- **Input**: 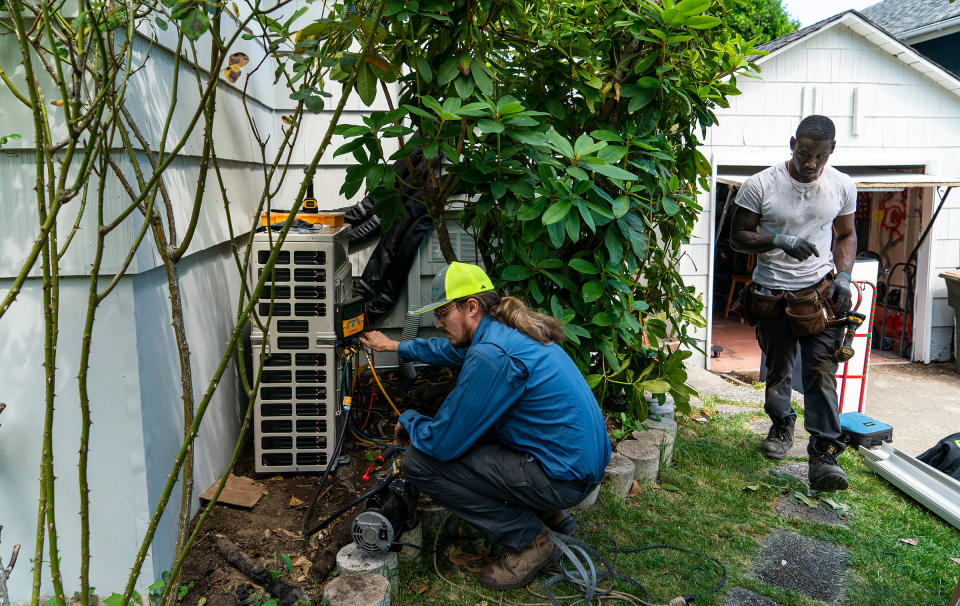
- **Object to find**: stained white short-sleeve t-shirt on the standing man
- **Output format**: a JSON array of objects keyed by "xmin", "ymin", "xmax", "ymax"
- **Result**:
[{"xmin": 735, "ymin": 162, "xmax": 857, "ymax": 290}]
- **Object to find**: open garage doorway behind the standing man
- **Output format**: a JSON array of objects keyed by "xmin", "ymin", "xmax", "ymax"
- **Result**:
[{"xmin": 708, "ymin": 166, "xmax": 960, "ymax": 382}]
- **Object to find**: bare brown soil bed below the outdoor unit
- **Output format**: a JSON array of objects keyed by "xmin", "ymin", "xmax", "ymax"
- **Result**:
[{"xmin": 181, "ymin": 368, "xmax": 456, "ymax": 606}]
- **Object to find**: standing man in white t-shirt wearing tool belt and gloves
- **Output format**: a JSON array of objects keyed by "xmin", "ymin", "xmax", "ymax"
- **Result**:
[{"xmin": 730, "ymin": 116, "xmax": 857, "ymax": 491}]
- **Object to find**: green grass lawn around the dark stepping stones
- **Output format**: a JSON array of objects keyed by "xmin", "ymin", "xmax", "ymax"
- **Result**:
[{"xmin": 393, "ymin": 403, "xmax": 960, "ymax": 606}]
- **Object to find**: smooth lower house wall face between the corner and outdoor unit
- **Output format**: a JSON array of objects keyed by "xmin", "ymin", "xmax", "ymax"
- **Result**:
[{"xmin": 131, "ymin": 244, "xmax": 246, "ymax": 588}]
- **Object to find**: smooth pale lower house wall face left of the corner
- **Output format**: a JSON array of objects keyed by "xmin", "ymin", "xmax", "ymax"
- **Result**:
[{"xmin": 0, "ymin": 278, "xmax": 153, "ymax": 601}]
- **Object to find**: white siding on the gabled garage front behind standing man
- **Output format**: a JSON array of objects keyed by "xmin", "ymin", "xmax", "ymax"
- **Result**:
[{"xmin": 690, "ymin": 15, "xmax": 960, "ymax": 370}]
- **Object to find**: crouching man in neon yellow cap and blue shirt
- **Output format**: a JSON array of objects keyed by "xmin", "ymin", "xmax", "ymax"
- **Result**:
[{"xmin": 362, "ymin": 262, "xmax": 610, "ymax": 590}]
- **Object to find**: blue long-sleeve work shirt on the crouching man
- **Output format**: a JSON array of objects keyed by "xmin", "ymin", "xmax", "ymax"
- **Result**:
[{"xmin": 397, "ymin": 316, "xmax": 610, "ymax": 482}]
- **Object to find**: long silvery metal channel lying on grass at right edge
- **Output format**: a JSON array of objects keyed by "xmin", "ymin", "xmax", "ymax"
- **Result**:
[{"xmin": 860, "ymin": 444, "xmax": 960, "ymax": 530}]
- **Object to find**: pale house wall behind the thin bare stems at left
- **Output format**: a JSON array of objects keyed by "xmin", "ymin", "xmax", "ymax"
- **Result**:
[{"xmin": 0, "ymin": 1, "xmax": 391, "ymax": 601}]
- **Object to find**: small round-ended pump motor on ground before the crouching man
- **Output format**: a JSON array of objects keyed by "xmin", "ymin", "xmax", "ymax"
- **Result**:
[{"xmin": 350, "ymin": 478, "xmax": 419, "ymax": 553}]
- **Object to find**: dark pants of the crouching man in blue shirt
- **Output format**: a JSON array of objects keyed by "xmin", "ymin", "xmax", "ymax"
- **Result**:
[{"xmin": 403, "ymin": 444, "xmax": 594, "ymax": 552}]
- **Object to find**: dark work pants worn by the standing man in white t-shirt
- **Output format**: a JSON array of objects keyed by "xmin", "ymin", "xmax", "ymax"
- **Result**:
[{"xmin": 757, "ymin": 311, "xmax": 843, "ymax": 452}]
